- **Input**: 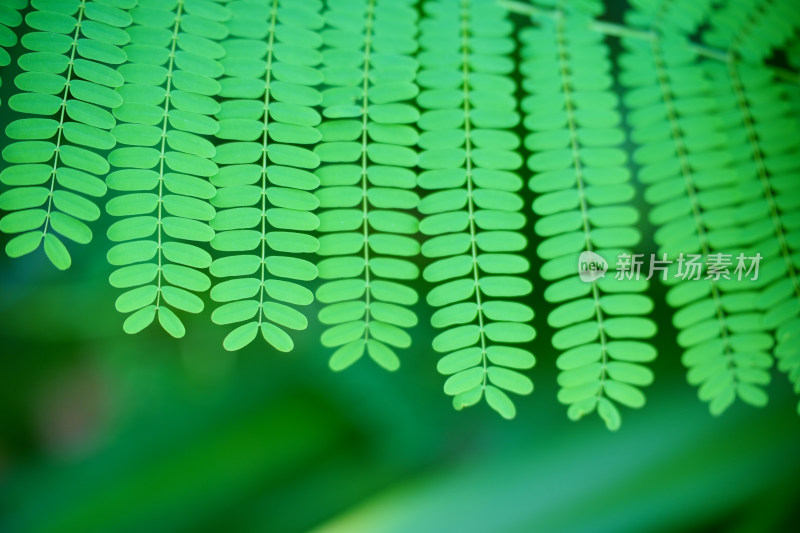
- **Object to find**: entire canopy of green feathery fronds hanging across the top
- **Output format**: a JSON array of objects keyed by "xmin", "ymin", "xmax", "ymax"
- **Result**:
[{"xmin": 0, "ymin": 0, "xmax": 800, "ymax": 424}]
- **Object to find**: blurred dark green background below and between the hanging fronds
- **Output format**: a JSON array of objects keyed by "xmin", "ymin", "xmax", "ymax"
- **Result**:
[{"xmin": 0, "ymin": 1, "xmax": 800, "ymax": 533}]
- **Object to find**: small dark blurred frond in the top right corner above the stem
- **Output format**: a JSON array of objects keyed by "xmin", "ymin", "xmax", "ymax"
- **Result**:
[{"xmin": 703, "ymin": 0, "xmax": 800, "ymax": 62}]
